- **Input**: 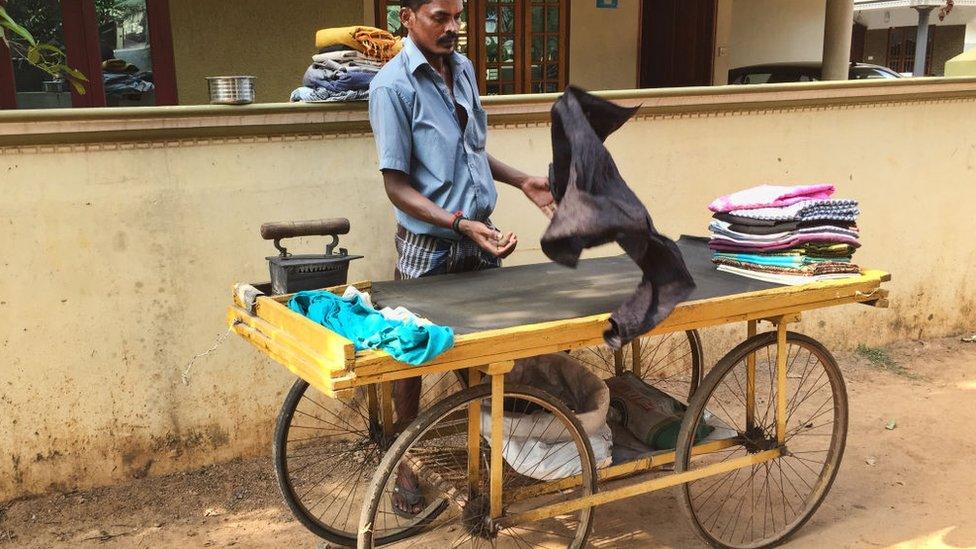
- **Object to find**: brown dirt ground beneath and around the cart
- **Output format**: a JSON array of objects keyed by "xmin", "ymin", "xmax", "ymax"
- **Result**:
[{"xmin": 0, "ymin": 337, "xmax": 976, "ymax": 549}]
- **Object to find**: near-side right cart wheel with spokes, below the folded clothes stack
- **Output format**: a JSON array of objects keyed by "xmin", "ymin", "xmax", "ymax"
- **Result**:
[{"xmin": 675, "ymin": 332, "xmax": 847, "ymax": 548}]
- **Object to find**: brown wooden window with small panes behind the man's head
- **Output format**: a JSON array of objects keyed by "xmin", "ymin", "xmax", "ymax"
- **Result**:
[{"xmin": 376, "ymin": 0, "xmax": 569, "ymax": 95}]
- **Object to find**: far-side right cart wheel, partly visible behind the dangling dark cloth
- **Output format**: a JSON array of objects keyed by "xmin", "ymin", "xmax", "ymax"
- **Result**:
[{"xmin": 573, "ymin": 330, "xmax": 705, "ymax": 402}]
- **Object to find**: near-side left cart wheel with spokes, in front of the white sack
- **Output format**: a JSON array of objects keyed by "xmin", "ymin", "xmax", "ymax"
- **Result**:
[{"xmin": 359, "ymin": 384, "xmax": 597, "ymax": 548}]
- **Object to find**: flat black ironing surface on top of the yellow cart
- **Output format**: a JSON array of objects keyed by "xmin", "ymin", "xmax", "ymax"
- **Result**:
[{"xmin": 370, "ymin": 236, "xmax": 778, "ymax": 334}]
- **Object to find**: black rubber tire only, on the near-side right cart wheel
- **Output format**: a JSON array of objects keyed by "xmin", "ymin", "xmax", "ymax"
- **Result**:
[{"xmin": 675, "ymin": 332, "xmax": 848, "ymax": 549}]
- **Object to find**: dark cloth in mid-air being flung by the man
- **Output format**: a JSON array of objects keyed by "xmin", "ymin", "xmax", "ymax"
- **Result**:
[{"xmin": 542, "ymin": 86, "xmax": 695, "ymax": 349}]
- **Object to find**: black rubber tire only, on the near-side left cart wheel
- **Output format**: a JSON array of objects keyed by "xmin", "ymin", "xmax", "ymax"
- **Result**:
[{"xmin": 357, "ymin": 384, "xmax": 597, "ymax": 548}]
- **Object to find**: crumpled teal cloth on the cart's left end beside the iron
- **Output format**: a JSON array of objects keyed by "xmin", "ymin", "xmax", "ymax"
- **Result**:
[{"xmin": 288, "ymin": 290, "xmax": 454, "ymax": 366}]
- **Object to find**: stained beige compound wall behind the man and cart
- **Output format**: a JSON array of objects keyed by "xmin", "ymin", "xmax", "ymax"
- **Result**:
[{"xmin": 0, "ymin": 83, "xmax": 976, "ymax": 501}]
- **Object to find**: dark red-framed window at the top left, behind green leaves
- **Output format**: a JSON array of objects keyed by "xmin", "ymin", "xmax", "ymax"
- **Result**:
[{"xmin": 0, "ymin": 0, "xmax": 177, "ymax": 109}]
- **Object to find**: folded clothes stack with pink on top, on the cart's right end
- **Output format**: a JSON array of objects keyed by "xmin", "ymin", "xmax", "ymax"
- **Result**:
[{"xmin": 708, "ymin": 185, "xmax": 861, "ymax": 285}]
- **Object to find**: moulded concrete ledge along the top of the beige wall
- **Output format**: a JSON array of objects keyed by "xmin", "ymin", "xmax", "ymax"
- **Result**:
[{"xmin": 0, "ymin": 77, "xmax": 976, "ymax": 147}]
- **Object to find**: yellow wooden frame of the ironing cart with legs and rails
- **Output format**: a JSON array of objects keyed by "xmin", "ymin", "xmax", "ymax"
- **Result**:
[{"xmin": 227, "ymin": 270, "xmax": 890, "ymax": 540}]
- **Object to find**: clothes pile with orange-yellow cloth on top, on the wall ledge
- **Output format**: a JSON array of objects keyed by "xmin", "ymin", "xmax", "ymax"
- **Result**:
[{"xmin": 291, "ymin": 27, "xmax": 402, "ymax": 103}]
